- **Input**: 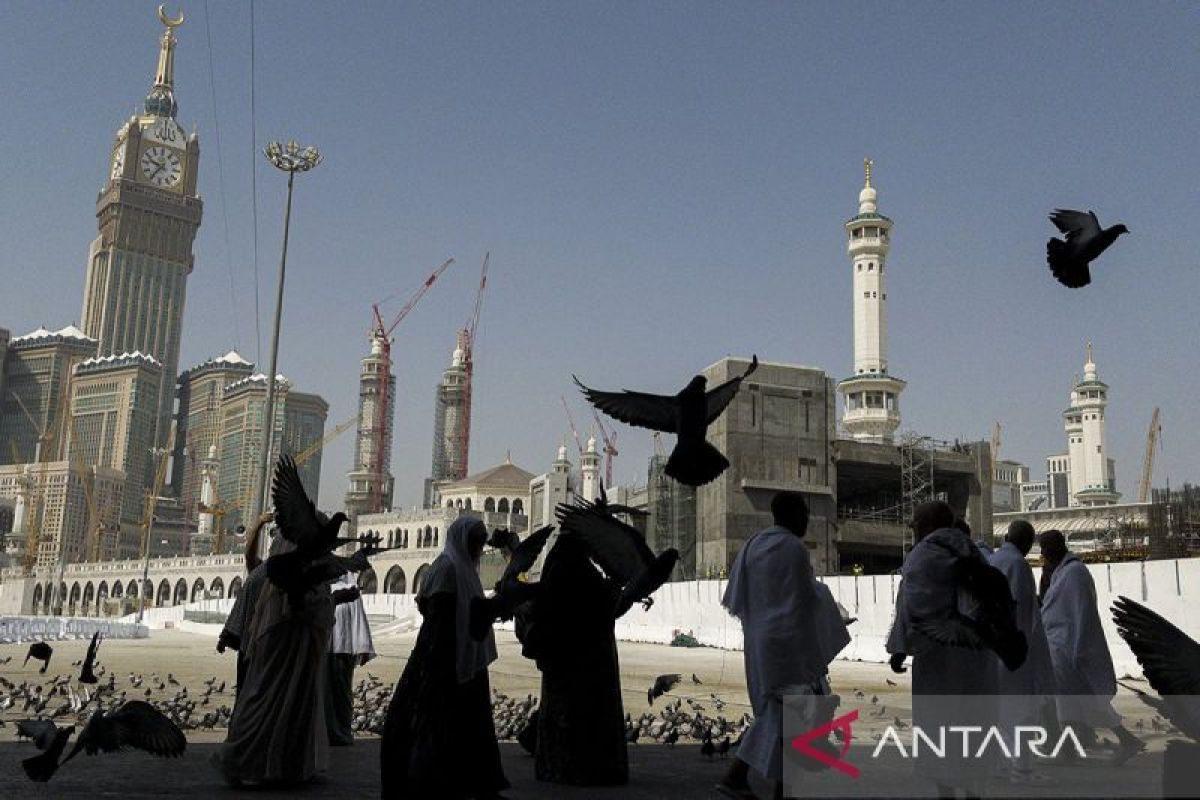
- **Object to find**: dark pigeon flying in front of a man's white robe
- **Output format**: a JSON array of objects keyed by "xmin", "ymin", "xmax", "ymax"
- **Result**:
[{"xmin": 912, "ymin": 558, "xmax": 1028, "ymax": 672}]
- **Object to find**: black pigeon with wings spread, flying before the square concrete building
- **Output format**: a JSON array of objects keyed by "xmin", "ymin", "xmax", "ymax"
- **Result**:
[{"xmin": 572, "ymin": 356, "xmax": 758, "ymax": 486}]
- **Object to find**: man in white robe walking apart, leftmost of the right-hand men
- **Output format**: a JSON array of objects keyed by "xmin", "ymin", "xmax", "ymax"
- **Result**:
[{"xmin": 716, "ymin": 492, "xmax": 850, "ymax": 799}]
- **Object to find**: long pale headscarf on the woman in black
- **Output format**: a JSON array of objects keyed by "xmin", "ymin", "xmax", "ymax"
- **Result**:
[{"xmin": 416, "ymin": 516, "xmax": 497, "ymax": 684}]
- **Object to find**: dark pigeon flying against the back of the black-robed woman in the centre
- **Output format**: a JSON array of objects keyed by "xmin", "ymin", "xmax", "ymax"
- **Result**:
[{"xmin": 554, "ymin": 500, "xmax": 679, "ymax": 616}]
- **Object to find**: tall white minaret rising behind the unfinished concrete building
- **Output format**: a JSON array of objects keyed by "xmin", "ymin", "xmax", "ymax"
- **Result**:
[{"xmin": 838, "ymin": 158, "xmax": 905, "ymax": 443}]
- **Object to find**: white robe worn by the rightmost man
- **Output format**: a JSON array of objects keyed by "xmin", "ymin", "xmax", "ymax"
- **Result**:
[{"xmin": 1042, "ymin": 553, "xmax": 1121, "ymax": 728}]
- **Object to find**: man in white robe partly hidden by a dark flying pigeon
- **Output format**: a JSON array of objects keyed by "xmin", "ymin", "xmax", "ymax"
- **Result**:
[{"xmin": 887, "ymin": 500, "xmax": 996, "ymax": 796}]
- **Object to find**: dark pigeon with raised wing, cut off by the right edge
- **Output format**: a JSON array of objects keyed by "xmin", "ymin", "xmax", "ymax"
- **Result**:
[{"xmin": 1112, "ymin": 596, "xmax": 1200, "ymax": 742}]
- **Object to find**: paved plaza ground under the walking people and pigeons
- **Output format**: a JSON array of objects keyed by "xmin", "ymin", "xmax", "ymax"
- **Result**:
[{"xmin": 0, "ymin": 631, "xmax": 1165, "ymax": 800}]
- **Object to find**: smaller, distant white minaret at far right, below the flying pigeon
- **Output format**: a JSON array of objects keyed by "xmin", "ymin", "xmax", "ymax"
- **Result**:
[{"xmin": 1063, "ymin": 342, "xmax": 1121, "ymax": 506}]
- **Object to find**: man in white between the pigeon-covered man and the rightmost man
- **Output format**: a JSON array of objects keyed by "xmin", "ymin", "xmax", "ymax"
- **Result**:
[{"xmin": 988, "ymin": 519, "xmax": 1055, "ymax": 786}]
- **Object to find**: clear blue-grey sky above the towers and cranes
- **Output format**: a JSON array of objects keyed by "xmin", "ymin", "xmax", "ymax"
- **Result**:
[{"xmin": 0, "ymin": 0, "xmax": 1200, "ymax": 506}]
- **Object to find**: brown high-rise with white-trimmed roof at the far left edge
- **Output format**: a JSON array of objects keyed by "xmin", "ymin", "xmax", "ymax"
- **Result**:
[{"xmin": 0, "ymin": 325, "xmax": 96, "ymax": 464}]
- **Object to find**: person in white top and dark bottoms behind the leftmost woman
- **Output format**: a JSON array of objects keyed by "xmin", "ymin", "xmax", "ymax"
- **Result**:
[{"xmin": 325, "ymin": 572, "xmax": 376, "ymax": 747}]
